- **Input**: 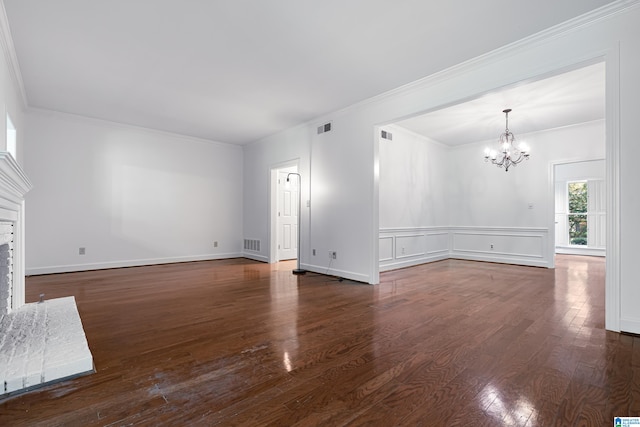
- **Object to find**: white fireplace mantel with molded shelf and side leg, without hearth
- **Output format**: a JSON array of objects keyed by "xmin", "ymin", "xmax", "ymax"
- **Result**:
[{"xmin": 0, "ymin": 151, "xmax": 33, "ymax": 310}]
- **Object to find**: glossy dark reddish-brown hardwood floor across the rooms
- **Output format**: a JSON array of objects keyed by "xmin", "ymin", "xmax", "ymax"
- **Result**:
[{"xmin": 0, "ymin": 256, "xmax": 640, "ymax": 426}]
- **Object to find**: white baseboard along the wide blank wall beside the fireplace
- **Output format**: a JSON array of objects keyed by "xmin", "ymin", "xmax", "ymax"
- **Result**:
[{"xmin": 25, "ymin": 252, "xmax": 244, "ymax": 276}]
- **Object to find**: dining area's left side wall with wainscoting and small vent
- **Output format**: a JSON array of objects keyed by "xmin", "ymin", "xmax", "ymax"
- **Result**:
[{"xmin": 378, "ymin": 125, "xmax": 450, "ymax": 271}]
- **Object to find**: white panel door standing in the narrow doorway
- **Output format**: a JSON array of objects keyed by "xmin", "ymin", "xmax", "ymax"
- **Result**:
[{"xmin": 278, "ymin": 170, "xmax": 299, "ymax": 261}]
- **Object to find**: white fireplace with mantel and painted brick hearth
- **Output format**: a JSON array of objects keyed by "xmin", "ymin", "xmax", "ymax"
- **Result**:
[{"xmin": 0, "ymin": 152, "xmax": 94, "ymax": 399}]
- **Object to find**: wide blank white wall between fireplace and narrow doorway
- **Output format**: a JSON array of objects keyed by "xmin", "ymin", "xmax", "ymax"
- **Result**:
[{"xmin": 25, "ymin": 110, "xmax": 242, "ymax": 274}]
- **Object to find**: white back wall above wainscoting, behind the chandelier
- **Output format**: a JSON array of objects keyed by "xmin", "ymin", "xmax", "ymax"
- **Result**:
[{"xmin": 449, "ymin": 121, "xmax": 605, "ymax": 227}]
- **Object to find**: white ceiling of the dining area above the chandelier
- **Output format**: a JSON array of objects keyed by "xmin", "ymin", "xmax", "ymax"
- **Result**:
[{"xmin": 396, "ymin": 62, "xmax": 605, "ymax": 146}]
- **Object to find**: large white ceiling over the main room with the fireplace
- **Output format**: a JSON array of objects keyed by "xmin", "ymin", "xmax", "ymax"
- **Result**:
[{"xmin": 5, "ymin": 0, "xmax": 612, "ymax": 144}]
